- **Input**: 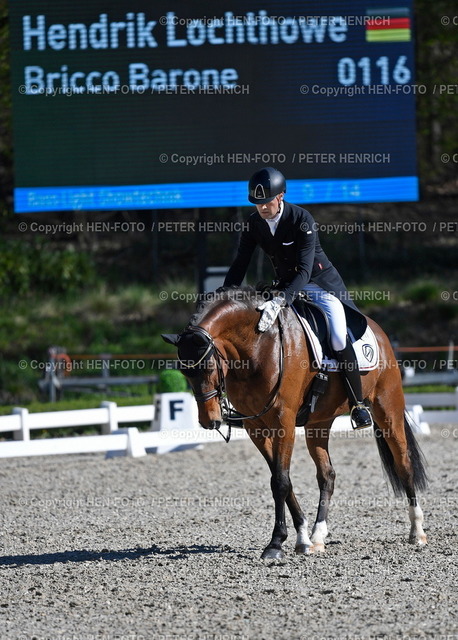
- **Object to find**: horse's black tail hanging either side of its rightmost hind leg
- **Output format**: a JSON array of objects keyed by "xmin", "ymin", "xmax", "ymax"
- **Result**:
[{"xmin": 374, "ymin": 411, "xmax": 428, "ymax": 496}]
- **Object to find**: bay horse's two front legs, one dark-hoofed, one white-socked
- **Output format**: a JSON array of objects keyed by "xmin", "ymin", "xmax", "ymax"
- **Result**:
[{"xmin": 245, "ymin": 424, "xmax": 312, "ymax": 557}]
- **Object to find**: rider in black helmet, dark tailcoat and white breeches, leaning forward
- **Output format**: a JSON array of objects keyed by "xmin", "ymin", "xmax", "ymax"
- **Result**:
[{"xmin": 224, "ymin": 167, "xmax": 373, "ymax": 429}]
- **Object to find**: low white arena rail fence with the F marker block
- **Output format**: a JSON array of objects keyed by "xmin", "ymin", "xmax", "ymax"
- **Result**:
[{"xmin": 0, "ymin": 388, "xmax": 452, "ymax": 457}]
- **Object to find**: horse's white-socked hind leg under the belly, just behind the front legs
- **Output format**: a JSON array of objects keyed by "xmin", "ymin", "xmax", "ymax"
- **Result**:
[{"xmin": 305, "ymin": 422, "xmax": 336, "ymax": 552}]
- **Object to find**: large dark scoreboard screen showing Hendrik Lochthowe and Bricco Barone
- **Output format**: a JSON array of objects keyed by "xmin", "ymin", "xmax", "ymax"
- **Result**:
[{"xmin": 9, "ymin": 0, "xmax": 418, "ymax": 212}]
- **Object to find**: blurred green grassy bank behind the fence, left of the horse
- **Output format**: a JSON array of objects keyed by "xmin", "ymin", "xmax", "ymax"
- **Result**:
[{"xmin": 0, "ymin": 281, "xmax": 194, "ymax": 405}]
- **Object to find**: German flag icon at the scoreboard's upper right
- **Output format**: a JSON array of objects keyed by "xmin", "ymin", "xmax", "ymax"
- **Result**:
[{"xmin": 366, "ymin": 7, "xmax": 411, "ymax": 42}]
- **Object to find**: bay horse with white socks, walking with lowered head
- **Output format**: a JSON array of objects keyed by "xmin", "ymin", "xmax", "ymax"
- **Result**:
[{"xmin": 162, "ymin": 287, "xmax": 427, "ymax": 560}]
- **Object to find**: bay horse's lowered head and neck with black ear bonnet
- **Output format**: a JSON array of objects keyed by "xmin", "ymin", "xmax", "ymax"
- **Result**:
[{"xmin": 162, "ymin": 287, "xmax": 276, "ymax": 429}]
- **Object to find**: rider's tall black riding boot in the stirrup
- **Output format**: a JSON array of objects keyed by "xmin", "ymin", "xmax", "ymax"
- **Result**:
[{"xmin": 335, "ymin": 337, "xmax": 374, "ymax": 429}]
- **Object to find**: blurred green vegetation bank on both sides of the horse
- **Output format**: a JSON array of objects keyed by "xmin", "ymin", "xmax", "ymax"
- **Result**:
[{"xmin": 0, "ymin": 276, "xmax": 458, "ymax": 407}]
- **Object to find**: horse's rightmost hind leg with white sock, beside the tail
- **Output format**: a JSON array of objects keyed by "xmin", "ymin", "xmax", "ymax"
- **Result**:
[{"xmin": 373, "ymin": 388, "xmax": 427, "ymax": 545}]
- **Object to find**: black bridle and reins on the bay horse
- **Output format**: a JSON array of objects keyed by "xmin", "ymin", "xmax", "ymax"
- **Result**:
[{"xmin": 178, "ymin": 316, "xmax": 284, "ymax": 442}]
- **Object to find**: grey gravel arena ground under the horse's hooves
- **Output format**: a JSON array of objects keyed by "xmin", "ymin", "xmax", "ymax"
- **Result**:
[{"xmin": 0, "ymin": 425, "xmax": 458, "ymax": 640}]
